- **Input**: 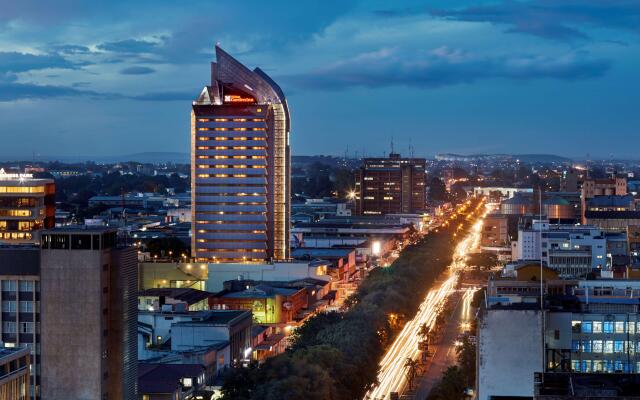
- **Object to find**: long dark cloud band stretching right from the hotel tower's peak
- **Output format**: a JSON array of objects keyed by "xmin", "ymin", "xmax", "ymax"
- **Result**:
[{"xmin": 282, "ymin": 47, "xmax": 610, "ymax": 90}]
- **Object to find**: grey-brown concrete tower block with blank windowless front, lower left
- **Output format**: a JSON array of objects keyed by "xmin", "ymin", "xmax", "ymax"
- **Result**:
[{"xmin": 40, "ymin": 227, "xmax": 137, "ymax": 400}]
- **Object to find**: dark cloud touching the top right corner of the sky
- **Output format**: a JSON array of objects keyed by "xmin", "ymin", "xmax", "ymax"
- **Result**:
[{"xmin": 430, "ymin": 0, "xmax": 640, "ymax": 41}]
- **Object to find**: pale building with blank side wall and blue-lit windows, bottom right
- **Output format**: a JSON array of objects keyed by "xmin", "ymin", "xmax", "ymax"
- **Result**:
[{"xmin": 477, "ymin": 274, "xmax": 640, "ymax": 400}]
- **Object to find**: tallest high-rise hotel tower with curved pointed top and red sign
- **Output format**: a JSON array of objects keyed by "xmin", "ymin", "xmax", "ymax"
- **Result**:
[{"xmin": 191, "ymin": 46, "xmax": 291, "ymax": 263}]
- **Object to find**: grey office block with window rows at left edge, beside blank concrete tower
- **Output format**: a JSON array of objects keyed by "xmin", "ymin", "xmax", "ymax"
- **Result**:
[{"xmin": 0, "ymin": 245, "xmax": 41, "ymax": 399}]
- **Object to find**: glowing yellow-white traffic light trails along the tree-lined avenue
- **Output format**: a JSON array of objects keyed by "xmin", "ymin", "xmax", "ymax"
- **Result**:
[{"xmin": 364, "ymin": 208, "xmax": 486, "ymax": 400}]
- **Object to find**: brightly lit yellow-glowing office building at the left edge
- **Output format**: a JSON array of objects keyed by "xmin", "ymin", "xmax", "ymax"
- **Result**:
[{"xmin": 0, "ymin": 169, "xmax": 56, "ymax": 243}]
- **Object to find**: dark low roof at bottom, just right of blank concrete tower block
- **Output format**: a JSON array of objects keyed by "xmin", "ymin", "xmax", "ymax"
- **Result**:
[{"xmin": 138, "ymin": 363, "xmax": 205, "ymax": 394}]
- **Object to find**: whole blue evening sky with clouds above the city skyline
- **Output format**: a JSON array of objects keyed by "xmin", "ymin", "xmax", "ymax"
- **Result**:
[{"xmin": 0, "ymin": 0, "xmax": 640, "ymax": 158}]
